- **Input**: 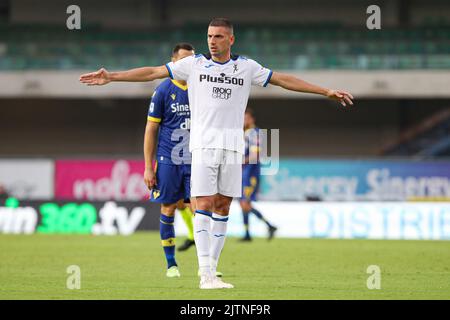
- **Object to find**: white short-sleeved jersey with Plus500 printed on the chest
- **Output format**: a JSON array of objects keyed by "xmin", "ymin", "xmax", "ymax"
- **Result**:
[{"xmin": 166, "ymin": 54, "xmax": 272, "ymax": 153}]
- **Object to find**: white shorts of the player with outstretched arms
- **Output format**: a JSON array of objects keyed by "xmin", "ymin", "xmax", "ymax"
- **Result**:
[{"xmin": 191, "ymin": 149, "xmax": 242, "ymax": 197}]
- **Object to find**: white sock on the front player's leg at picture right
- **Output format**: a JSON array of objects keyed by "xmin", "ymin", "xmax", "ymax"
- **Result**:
[{"xmin": 209, "ymin": 213, "xmax": 228, "ymax": 276}]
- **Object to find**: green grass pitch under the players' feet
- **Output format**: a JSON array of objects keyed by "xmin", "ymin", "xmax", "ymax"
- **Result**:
[{"xmin": 0, "ymin": 232, "xmax": 450, "ymax": 300}]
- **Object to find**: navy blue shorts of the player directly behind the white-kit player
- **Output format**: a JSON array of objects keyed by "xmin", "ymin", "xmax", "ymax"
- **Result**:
[{"xmin": 150, "ymin": 163, "xmax": 191, "ymax": 204}]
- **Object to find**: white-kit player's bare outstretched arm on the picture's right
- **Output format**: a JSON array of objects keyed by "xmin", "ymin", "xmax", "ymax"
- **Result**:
[{"xmin": 270, "ymin": 72, "xmax": 353, "ymax": 107}]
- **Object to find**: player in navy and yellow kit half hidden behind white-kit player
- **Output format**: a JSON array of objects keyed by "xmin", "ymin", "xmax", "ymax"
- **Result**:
[{"xmin": 144, "ymin": 43, "xmax": 195, "ymax": 277}]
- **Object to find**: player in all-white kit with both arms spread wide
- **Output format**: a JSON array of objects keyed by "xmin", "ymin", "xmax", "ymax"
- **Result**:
[{"xmin": 80, "ymin": 18, "xmax": 353, "ymax": 289}]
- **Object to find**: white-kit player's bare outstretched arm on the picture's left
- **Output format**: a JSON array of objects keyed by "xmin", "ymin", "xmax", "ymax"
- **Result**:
[{"xmin": 80, "ymin": 66, "xmax": 169, "ymax": 86}]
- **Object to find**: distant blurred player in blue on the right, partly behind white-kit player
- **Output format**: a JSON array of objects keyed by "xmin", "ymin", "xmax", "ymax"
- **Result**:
[{"xmin": 239, "ymin": 108, "xmax": 277, "ymax": 241}]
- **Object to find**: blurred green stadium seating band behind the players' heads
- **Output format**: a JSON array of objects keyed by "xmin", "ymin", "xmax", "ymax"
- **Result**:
[{"xmin": 0, "ymin": 24, "xmax": 450, "ymax": 70}]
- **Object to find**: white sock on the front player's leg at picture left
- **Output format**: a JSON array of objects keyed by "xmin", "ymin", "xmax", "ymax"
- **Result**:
[{"xmin": 194, "ymin": 210, "xmax": 211, "ymax": 276}]
